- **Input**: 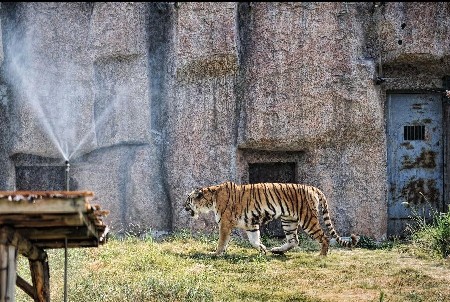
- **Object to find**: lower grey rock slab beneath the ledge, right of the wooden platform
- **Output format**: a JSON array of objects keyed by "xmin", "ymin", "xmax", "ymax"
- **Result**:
[{"xmin": 71, "ymin": 144, "xmax": 171, "ymax": 234}]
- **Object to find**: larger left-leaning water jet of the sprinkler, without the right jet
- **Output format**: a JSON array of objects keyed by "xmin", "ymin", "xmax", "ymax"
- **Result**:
[{"xmin": 8, "ymin": 31, "xmax": 86, "ymax": 160}]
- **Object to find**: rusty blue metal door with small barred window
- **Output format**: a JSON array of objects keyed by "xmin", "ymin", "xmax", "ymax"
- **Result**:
[{"xmin": 387, "ymin": 94, "xmax": 444, "ymax": 236}]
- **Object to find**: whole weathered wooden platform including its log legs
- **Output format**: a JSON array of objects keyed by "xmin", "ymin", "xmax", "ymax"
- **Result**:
[{"xmin": 0, "ymin": 191, "xmax": 108, "ymax": 302}]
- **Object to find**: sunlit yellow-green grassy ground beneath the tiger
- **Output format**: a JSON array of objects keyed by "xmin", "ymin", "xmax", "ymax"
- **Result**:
[{"xmin": 17, "ymin": 232, "xmax": 450, "ymax": 302}]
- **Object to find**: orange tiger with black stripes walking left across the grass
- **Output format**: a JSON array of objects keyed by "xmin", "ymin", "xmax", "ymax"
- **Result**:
[{"xmin": 184, "ymin": 181, "xmax": 358, "ymax": 256}]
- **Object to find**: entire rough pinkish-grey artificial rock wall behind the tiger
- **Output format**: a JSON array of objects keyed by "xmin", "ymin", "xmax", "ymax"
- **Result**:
[{"xmin": 0, "ymin": 2, "xmax": 450, "ymax": 239}]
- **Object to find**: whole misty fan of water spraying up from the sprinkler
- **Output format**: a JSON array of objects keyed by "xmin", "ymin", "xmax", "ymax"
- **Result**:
[{"xmin": 4, "ymin": 6, "xmax": 146, "ymax": 161}]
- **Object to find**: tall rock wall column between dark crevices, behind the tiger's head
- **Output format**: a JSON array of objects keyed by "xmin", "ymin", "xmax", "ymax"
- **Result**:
[{"xmin": 166, "ymin": 2, "xmax": 238, "ymax": 228}]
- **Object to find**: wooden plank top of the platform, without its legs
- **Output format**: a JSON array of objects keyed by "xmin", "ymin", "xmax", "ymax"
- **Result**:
[{"xmin": 0, "ymin": 191, "xmax": 109, "ymax": 248}]
